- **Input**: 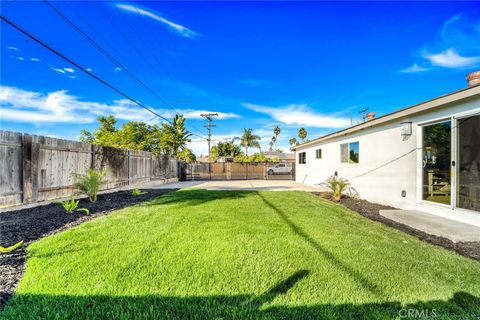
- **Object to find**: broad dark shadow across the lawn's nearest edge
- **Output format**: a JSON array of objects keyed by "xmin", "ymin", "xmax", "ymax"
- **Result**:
[{"xmin": 0, "ymin": 290, "xmax": 480, "ymax": 320}]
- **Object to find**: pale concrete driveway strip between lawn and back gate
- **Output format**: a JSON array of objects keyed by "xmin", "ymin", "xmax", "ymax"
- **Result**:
[{"xmin": 155, "ymin": 180, "xmax": 321, "ymax": 192}]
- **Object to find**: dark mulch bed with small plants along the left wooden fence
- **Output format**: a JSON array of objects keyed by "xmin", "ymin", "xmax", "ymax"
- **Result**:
[{"xmin": 0, "ymin": 189, "xmax": 177, "ymax": 310}]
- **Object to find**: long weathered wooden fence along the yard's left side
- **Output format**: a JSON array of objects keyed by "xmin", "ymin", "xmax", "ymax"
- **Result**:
[{"xmin": 0, "ymin": 130, "xmax": 177, "ymax": 206}]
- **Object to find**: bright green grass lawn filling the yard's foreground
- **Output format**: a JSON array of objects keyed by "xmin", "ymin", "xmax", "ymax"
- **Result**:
[{"xmin": 0, "ymin": 189, "xmax": 480, "ymax": 319}]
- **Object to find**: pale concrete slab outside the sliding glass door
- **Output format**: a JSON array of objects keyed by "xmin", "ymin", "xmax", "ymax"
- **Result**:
[{"xmin": 380, "ymin": 210, "xmax": 480, "ymax": 242}]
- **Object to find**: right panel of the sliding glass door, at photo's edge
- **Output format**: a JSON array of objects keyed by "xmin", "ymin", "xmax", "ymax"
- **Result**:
[{"xmin": 456, "ymin": 115, "xmax": 480, "ymax": 211}]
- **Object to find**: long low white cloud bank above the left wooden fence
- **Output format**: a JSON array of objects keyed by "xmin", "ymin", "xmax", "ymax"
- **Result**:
[{"xmin": 0, "ymin": 87, "xmax": 238, "ymax": 127}]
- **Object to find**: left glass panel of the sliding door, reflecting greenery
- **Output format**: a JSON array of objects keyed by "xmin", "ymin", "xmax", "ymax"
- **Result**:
[{"xmin": 422, "ymin": 120, "xmax": 452, "ymax": 205}]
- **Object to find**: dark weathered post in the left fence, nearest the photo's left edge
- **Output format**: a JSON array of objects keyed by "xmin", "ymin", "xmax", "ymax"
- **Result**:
[{"xmin": 22, "ymin": 134, "xmax": 40, "ymax": 203}]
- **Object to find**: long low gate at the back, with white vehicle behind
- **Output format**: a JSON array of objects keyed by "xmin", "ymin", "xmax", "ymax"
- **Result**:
[{"xmin": 186, "ymin": 162, "xmax": 295, "ymax": 180}]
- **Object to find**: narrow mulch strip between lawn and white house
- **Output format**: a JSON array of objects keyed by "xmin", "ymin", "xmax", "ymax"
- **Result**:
[{"xmin": 314, "ymin": 192, "xmax": 480, "ymax": 261}]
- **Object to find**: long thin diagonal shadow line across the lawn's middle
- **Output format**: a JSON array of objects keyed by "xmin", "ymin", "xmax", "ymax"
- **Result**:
[{"xmin": 257, "ymin": 193, "xmax": 384, "ymax": 296}]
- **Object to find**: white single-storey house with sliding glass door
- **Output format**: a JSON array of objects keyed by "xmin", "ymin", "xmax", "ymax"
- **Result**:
[{"xmin": 293, "ymin": 72, "xmax": 480, "ymax": 226}]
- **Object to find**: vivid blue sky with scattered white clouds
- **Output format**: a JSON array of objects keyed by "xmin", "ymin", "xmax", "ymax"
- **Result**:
[{"xmin": 0, "ymin": 1, "xmax": 480, "ymax": 154}]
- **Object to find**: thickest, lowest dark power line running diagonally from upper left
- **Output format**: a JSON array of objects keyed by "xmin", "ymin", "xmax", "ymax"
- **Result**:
[{"xmin": 0, "ymin": 15, "xmax": 171, "ymax": 123}]
